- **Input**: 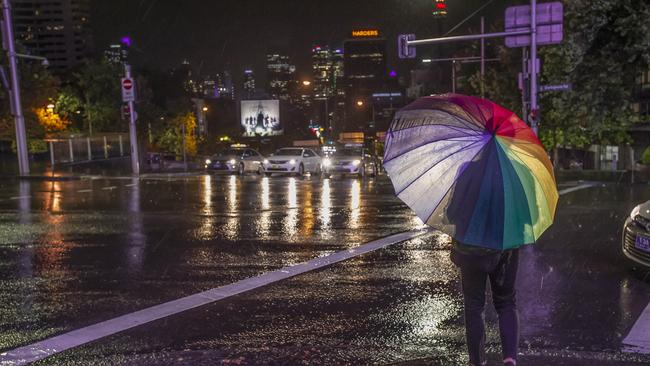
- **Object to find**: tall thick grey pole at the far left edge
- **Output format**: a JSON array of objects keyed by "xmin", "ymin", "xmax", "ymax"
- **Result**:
[{"xmin": 2, "ymin": 0, "xmax": 29, "ymax": 176}]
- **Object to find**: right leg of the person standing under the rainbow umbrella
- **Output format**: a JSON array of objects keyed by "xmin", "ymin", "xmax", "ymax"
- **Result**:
[{"xmin": 489, "ymin": 249, "xmax": 519, "ymax": 364}]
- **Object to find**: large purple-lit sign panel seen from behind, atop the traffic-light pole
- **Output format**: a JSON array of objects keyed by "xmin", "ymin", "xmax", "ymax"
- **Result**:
[{"xmin": 505, "ymin": 2, "xmax": 564, "ymax": 48}]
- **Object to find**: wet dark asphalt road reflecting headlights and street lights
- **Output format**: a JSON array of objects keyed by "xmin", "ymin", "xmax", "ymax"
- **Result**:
[{"xmin": 0, "ymin": 176, "xmax": 650, "ymax": 365}]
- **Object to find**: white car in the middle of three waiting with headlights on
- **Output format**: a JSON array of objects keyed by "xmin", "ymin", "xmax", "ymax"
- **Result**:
[{"xmin": 264, "ymin": 147, "xmax": 322, "ymax": 176}]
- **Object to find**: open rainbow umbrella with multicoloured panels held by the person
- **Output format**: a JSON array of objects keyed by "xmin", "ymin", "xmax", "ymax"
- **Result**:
[{"xmin": 384, "ymin": 94, "xmax": 558, "ymax": 250}]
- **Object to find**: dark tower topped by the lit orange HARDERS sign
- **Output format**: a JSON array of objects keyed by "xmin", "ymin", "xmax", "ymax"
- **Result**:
[{"xmin": 340, "ymin": 29, "xmax": 387, "ymax": 132}]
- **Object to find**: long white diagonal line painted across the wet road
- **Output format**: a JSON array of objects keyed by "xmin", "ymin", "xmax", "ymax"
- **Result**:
[{"xmin": 0, "ymin": 230, "xmax": 430, "ymax": 366}]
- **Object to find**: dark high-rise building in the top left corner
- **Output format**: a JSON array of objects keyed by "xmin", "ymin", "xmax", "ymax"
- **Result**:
[{"xmin": 12, "ymin": 0, "xmax": 92, "ymax": 71}]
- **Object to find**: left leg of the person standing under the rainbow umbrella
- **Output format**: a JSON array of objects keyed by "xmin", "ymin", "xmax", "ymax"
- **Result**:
[{"xmin": 461, "ymin": 267, "xmax": 487, "ymax": 365}]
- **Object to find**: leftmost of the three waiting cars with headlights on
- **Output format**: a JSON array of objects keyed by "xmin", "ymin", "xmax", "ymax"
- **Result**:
[{"xmin": 205, "ymin": 145, "xmax": 264, "ymax": 175}]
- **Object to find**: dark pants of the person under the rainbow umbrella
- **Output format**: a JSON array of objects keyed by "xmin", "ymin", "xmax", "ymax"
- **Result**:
[{"xmin": 452, "ymin": 249, "xmax": 519, "ymax": 365}]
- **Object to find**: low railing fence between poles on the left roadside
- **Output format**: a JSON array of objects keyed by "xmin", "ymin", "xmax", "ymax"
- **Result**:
[{"xmin": 46, "ymin": 133, "xmax": 130, "ymax": 165}]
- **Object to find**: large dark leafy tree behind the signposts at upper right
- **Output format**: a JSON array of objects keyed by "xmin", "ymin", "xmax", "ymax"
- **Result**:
[{"xmin": 540, "ymin": 0, "xmax": 650, "ymax": 155}]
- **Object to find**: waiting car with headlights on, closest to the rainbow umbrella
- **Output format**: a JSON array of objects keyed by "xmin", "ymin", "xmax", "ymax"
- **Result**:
[{"xmin": 323, "ymin": 145, "xmax": 379, "ymax": 177}]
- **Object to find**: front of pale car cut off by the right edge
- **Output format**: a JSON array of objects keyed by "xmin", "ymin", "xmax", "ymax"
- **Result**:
[{"xmin": 622, "ymin": 201, "xmax": 650, "ymax": 269}]
